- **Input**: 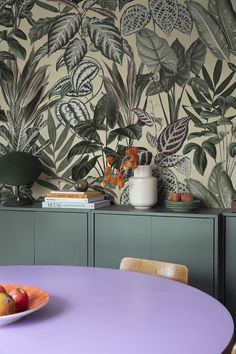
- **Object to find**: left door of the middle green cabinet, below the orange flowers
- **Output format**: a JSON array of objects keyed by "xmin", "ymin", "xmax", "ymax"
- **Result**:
[{"xmin": 94, "ymin": 214, "xmax": 151, "ymax": 268}]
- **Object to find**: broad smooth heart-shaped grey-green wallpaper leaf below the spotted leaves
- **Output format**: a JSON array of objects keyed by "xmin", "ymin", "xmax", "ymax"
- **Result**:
[{"xmin": 136, "ymin": 29, "xmax": 177, "ymax": 74}]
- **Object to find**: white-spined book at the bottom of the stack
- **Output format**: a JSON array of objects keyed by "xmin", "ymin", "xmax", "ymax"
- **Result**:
[{"xmin": 42, "ymin": 200, "xmax": 110, "ymax": 209}]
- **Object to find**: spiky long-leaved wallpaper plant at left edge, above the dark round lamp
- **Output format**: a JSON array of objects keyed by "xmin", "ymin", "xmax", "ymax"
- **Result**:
[{"xmin": 0, "ymin": 51, "xmax": 49, "ymax": 155}]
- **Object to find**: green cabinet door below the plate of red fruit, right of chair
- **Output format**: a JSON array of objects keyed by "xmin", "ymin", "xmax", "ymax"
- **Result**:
[{"xmin": 152, "ymin": 216, "xmax": 218, "ymax": 296}]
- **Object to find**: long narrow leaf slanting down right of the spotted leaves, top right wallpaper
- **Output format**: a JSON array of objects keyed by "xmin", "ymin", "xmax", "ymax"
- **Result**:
[{"xmin": 187, "ymin": 1, "xmax": 230, "ymax": 61}]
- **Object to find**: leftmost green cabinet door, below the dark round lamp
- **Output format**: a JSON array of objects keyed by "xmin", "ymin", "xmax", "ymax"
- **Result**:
[{"xmin": 0, "ymin": 209, "xmax": 34, "ymax": 265}]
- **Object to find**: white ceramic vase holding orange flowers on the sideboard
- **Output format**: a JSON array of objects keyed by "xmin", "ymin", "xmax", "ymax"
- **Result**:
[{"xmin": 129, "ymin": 165, "xmax": 157, "ymax": 209}]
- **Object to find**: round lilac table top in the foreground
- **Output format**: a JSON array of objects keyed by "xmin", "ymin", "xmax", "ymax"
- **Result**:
[{"xmin": 0, "ymin": 266, "xmax": 233, "ymax": 354}]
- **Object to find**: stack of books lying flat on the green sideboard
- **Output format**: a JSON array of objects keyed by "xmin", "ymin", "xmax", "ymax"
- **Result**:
[{"xmin": 42, "ymin": 190, "xmax": 110, "ymax": 209}]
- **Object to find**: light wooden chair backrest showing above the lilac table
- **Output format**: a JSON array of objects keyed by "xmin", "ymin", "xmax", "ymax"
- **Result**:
[{"xmin": 120, "ymin": 257, "xmax": 188, "ymax": 284}]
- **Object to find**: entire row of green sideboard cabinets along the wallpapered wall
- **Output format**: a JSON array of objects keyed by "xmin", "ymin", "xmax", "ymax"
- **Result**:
[{"xmin": 0, "ymin": 203, "xmax": 236, "ymax": 319}]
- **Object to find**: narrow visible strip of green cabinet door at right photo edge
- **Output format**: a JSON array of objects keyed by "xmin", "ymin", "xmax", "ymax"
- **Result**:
[{"xmin": 224, "ymin": 214, "xmax": 236, "ymax": 325}]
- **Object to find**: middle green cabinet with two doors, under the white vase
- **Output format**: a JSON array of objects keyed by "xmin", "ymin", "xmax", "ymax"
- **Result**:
[{"xmin": 92, "ymin": 206, "xmax": 223, "ymax": 299}]
